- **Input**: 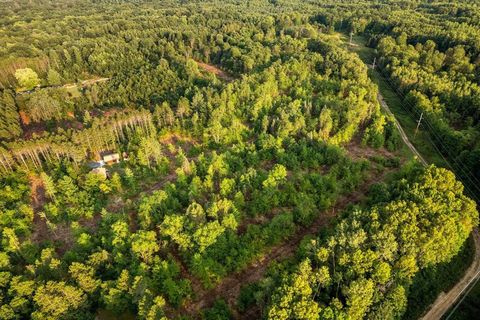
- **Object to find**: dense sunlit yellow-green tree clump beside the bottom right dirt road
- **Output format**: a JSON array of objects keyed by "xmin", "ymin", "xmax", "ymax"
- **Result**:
[{"xmin": 267, "ymin": 167, "xmax": 478, "ymax": 319}]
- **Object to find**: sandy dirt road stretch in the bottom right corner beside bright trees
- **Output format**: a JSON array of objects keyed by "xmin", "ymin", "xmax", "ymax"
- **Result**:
[{"xmin": 422, "ymin": 230, "xmax": 480, "ymax": 320}]
